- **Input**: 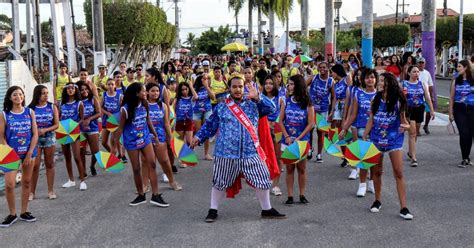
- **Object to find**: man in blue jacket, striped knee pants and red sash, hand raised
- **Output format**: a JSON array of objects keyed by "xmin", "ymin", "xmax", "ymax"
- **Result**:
[{"xmin": 191, "ymin": 76, "xmax": 286, "ymax": 222}]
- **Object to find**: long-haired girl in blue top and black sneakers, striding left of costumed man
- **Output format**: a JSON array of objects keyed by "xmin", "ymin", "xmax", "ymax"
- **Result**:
[{"xmin": 115, "ymin": 83, "xmax": 169, "ymax": 207}]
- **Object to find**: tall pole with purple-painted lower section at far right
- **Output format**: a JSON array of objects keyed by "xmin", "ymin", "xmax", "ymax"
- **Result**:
[{"xmin": 421, "ymin": 0, "xmax": 437, "ymax": 106}]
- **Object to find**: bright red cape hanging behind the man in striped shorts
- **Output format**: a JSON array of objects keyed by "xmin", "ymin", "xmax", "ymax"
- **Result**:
[{"xmin": 226, "ymin": 116, "xmax": 280, "ymax": 198}]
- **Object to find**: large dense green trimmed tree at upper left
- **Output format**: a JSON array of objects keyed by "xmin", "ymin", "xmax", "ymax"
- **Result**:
[{"xmin": 84, "ymin": 0, "xmax": 176, "ymax": 69}]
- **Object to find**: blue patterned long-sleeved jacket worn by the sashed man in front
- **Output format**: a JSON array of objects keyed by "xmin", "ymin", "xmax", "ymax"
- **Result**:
[{"xmin": 196, "ymin": 94, "xmax": 276, "ymax": 159}]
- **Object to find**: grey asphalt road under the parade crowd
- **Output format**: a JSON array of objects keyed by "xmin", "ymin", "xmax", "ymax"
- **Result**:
[{"xmin": 0, "ymin": 126, "xmax": 474, "ymax": 247}]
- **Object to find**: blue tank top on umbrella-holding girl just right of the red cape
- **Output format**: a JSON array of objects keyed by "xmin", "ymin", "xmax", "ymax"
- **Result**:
[{"xmin": 281, "ymin": 97, "xmax": 309, "ymax": 144}]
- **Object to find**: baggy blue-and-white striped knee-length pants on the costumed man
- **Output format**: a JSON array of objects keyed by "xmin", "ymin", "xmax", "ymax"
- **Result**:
[{"xmin": 212, "ymin": 156, "xmax": 272, "ymax": 191}]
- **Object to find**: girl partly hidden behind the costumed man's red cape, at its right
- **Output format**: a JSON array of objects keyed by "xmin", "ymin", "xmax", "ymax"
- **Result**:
[{"xmin": 263, "ymin": 76, "xmax": 286, "ymax": 196}]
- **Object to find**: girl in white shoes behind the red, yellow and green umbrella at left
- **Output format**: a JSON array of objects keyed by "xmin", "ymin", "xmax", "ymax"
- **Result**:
[{"xmin": 59, "ymin": 83, "xmax": 87, "ymax": 190}]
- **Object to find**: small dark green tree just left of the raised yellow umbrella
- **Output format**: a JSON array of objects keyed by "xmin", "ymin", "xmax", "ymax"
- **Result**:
[{"xmin": 195, "ymin": 25, "xmax": 232, "ymax": 55}]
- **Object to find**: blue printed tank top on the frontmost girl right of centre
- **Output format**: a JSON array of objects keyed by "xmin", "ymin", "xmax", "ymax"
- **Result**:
[{"xmin": 370, "ymin": 100, "xmax": 404, "ymax": 152}]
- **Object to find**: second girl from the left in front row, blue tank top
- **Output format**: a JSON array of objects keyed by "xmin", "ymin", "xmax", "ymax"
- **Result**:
[{"xmin": 28, "ymin": 84, "xmax": 59, "ymax": 200}]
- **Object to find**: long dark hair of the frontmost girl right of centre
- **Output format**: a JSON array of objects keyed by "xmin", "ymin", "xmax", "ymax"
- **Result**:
[{"xmin": 371, "ymin": 72, "xmax": 407, "ymax": 115}]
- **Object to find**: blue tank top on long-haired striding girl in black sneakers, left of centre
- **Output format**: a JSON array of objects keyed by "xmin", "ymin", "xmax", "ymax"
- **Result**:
[{"xmin": 122, "ymin": 104, "xmax": 151, "ymax": 150}]
